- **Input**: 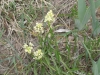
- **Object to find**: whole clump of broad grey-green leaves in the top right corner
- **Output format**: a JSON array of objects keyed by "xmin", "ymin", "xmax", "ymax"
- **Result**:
[{"xmin": 75, "ymin": 0, "xmax": 100, "ymax": 35}]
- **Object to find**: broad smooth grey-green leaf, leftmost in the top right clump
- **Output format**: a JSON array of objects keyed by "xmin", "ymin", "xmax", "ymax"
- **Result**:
[{"xmin": 75, "ymin": 0, "xmax": 91, "ymax": 30}]
